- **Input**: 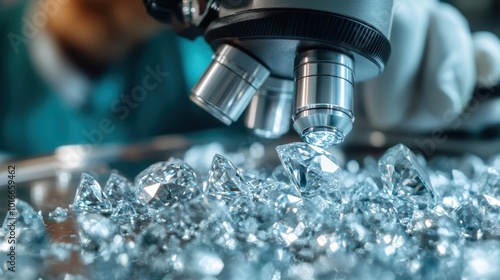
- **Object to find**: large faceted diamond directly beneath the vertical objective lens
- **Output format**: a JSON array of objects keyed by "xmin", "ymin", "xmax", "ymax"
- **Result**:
[{"xmin": 276, "ymin": 143, "xmax": 341, "ymax": 193}]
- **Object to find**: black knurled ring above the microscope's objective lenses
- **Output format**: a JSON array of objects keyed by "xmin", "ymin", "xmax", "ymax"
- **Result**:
[{"xmin": 205, "ymin": 8, "xmax": 391, "ymax": 75}]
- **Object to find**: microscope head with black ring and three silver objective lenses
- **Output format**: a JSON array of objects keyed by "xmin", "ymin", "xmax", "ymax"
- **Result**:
[{"xmin": 144, "ymin": 0, "xmax": 393, "ymax": 146}]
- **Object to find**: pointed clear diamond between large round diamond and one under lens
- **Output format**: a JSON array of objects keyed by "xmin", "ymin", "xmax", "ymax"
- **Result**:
[{"xmin": 208, "ymin": 155, "xmax": 250, "ymax": 195}]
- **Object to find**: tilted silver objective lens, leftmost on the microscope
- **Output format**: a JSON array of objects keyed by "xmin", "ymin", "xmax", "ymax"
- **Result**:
[{"xmin": 190, "ymin": 45, "xmax": 270, "ymax": 125}]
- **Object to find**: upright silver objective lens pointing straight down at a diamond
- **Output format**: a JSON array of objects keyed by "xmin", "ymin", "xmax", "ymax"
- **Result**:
[{"xmin": 293, "ymin": 50, "xmax": 354, "ymax": 146}]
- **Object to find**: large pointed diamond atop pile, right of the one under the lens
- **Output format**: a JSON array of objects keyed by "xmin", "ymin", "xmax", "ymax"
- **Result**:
[{"xmin": 378, "ymin": 144, "xmax": 435, "ymax": 205}]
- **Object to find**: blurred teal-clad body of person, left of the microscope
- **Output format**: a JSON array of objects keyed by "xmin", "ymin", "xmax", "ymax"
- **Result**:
[{"xmin": 0, "ymin": 0, "xmax": 219, "ymax": 156}]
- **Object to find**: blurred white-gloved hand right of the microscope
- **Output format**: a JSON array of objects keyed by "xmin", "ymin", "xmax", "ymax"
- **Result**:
[{"xmin": 357, "ymin": 0, "xmax": 500, "ymax": 133}]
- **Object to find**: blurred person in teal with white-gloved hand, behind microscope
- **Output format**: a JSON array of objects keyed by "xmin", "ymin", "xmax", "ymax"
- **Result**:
[{"xmin": 0, "ymin": 0, "xmax": 500, "ymax": 158}]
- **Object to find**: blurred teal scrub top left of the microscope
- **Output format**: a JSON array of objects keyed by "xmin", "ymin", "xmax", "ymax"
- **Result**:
[{"xmin": 0, "ymin": 1, "xmax": 218, "ymax": 156}]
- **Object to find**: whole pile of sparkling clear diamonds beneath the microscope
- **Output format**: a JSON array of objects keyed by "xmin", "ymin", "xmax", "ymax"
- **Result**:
[{"xmin": 0, "ymin": 143, "xmax": 500, "ymax": 279}]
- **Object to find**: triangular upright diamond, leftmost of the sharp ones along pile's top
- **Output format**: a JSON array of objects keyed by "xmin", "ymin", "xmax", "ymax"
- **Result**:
[{"xmin": 73, "ymin": 173, "xmax": 112, "ymax": 213}]
